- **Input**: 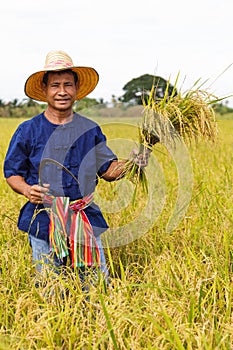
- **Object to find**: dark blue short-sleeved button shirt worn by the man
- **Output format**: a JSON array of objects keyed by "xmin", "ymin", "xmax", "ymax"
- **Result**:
[{"xmin": 4, "ymin": 113, "xmax": 117, "ymax": 241}]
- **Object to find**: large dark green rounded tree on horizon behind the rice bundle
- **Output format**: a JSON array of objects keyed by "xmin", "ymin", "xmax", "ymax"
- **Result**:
[{"xmin": 120, "ymin": 74, "xmax": 174, "ymax": 105}]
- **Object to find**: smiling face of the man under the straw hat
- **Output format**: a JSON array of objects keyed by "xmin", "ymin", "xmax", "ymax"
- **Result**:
[{"xmin": 42, "ymin": 72, "xmax": 78, "ymax": 111}]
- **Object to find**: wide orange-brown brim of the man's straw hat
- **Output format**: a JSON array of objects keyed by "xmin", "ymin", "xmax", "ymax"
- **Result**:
[{"xmin": 24, "ymin": 67, "xmax": 99, "ymax": 102}]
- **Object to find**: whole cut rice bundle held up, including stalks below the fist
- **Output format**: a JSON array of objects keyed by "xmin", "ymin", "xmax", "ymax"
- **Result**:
[{"xmin": 125, "ymin": 76, "xmax": 222, "ymax": 196}]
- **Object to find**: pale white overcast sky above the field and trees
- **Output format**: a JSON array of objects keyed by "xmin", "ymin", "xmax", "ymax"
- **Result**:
[{"xmin": 0, "ymin": 0, "xmax": 233, "ymax": 106}]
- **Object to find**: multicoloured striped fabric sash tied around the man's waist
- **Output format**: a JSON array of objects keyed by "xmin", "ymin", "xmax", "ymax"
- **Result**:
[{"xmin": 44, "ymin": 194, "xmax": 100, "ymax": 267}]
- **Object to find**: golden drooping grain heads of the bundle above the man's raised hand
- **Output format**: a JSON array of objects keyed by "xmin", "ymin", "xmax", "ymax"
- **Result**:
[{"xmin": 140, "ymin": 77, "xmax": 220, "ymax": 143}]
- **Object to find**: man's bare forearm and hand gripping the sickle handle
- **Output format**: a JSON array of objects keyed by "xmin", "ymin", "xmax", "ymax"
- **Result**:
[{"xmin": 6, "ymin": 175, "xmax": 49, "ymax": 204}]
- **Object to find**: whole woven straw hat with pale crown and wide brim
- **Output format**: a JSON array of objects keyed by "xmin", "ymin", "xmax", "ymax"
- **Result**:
[{"xmin": 24, "ymin": 51, "xmax": 99, "ymax": 102}]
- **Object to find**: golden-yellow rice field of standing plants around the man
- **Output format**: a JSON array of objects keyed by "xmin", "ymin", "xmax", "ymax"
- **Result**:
[{"xmin": 0, "ymin": 117, "xmax": 233, "ymax": 350}]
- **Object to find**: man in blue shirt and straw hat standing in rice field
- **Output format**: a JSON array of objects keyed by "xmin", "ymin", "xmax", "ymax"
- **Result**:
[{"xmin": 4, "ymin": 51, "xmax": 147, "ymax": 284}]
